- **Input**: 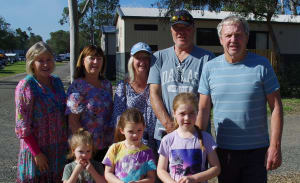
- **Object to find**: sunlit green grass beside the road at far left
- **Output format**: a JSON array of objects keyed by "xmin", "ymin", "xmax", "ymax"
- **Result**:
[{"xmin": 0, "ymin": 61, "xmax": 65, "ymax": 78}]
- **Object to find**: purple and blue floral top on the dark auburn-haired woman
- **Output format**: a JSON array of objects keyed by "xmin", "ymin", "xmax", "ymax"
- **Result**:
[{"xmin": 66, "ymin": 79, "xmax": 114, "ymax": 150}]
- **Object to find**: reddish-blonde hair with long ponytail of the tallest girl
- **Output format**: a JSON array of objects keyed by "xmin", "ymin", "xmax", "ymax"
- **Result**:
[{"xmin": 172, "ymin": 92, "xmax": 205, "ymax": 151}]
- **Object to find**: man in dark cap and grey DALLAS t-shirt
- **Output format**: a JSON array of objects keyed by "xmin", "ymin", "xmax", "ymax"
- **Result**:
[{"xmin": 148, "ymin": 10, "xmax": 214, "ymax": 143}]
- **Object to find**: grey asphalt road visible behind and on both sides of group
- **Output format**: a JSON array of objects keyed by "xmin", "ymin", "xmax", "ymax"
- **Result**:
[{"xmin": 0, "ymin": 61, "xmax": 300, "ymax": 183}]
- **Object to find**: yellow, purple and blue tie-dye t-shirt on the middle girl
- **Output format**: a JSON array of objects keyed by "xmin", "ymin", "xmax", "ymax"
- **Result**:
[{"xmin": 102, "ymin": 141, "xmax": 156, "ymax": 183}]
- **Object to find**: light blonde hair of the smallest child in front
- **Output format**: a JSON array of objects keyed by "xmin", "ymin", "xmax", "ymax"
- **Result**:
[{"xmin": 67, "ymin": 128, "xmax": 94, "ymax": 159}]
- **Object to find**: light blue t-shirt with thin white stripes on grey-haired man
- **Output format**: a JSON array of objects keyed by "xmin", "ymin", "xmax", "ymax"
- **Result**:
[{"xmin": 199, "ymin": 53, "xmax": 279, "ymax": 150}]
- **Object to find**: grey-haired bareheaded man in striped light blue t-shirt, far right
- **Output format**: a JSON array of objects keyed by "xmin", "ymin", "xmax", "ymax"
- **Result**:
[{"xmin": 198, "ymin": 16, "xmax": 283, "ymax": 183}]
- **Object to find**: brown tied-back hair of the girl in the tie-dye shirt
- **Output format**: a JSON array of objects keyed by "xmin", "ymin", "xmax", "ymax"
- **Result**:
[{"xmin": 114, "ymin": 108, "xmax": 145, "ymax": 142}]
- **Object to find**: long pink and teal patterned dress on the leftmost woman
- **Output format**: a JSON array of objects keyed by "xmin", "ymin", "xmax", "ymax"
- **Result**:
[{"xmin": 15, "ymin": 75, "xmax": 67, "ymax": 183}]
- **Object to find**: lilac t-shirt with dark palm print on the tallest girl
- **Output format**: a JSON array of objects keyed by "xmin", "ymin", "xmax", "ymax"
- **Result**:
[{"xmin": 158, "ymin": 130, "xmax": 217, "ymax": 181}]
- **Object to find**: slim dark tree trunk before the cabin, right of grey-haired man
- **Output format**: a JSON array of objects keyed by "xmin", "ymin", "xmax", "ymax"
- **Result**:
[{"xmin": 267, "ymin": 18, "xmax": 283, "ymax": 73}]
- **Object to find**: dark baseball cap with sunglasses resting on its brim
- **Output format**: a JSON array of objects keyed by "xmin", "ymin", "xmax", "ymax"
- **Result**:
[{"xmin": 170, "ymin": 10, "xmax": 194, "ymax": 26}]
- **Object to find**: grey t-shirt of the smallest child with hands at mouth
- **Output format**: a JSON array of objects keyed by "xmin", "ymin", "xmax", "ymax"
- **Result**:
[{"xmin": 62, "ymin": 160, "xmax": 104, "ymax": 183}]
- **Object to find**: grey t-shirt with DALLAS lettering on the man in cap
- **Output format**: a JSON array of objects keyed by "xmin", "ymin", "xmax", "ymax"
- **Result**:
[{"xmin": 148, "ymin": 46, "xmax": 215, "ymax": 140}]
